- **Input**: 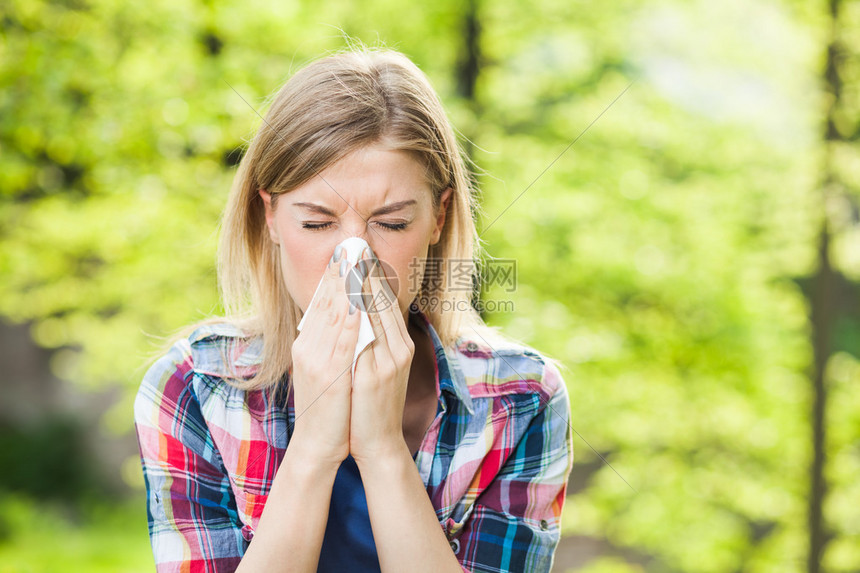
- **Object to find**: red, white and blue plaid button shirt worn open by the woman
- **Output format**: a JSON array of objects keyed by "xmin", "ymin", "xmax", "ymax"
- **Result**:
[{"xmin": 134, "ymin": 314, "xmax": 573, "ymax": 573}]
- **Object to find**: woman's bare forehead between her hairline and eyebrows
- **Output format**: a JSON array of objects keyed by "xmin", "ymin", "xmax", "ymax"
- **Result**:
[{"xmin": 289, "ymin": 146, "xmax": 430, "ymax": 208}]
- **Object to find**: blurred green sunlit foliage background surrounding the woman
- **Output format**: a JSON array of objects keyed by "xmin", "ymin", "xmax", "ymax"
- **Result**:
[{"xmin": 0, "ymin": 0, "xmax": 860, "ymax": 573}]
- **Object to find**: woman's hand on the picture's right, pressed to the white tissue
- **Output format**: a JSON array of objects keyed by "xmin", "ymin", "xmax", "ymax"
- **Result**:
[{"xmin": 349, "ymin": 250, "xmax": 415, "ymax": 466}]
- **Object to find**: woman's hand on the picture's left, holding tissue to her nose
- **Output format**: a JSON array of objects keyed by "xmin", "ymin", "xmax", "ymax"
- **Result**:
[{"xmin": 289, "ymin": 249, "xmax": 360, "ymax": 468}]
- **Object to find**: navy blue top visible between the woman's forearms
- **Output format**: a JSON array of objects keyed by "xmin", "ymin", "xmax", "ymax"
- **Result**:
[{"xmin": 317, "ymin": 452, "xmax": 417, "ymax": 573}]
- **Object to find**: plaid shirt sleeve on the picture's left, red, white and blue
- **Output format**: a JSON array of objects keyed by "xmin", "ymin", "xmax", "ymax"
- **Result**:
[{"xmin": 134, "ymin": 340, "xmax": 248, "ymax": 573}]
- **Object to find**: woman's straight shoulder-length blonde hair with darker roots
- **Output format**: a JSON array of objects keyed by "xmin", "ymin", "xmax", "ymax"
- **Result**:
[{"xmin": 182, "ymin": 47, "xmax": 552, "ymax": 390}]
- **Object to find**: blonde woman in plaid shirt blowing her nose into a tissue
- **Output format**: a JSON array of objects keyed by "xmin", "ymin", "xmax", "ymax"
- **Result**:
[{"xmin": 135, "ymin": 45, "xmax": 573, "ymax": 573}]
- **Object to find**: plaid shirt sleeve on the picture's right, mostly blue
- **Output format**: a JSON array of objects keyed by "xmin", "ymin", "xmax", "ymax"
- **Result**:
[{"xmin": 452, "ymin": 363, "xmax": 573, "ymax": 573}]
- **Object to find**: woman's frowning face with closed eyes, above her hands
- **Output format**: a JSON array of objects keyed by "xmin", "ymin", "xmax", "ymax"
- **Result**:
[{"xmin": 260, "ymin": 145, "xmax": 451, "ymax": 318}]
